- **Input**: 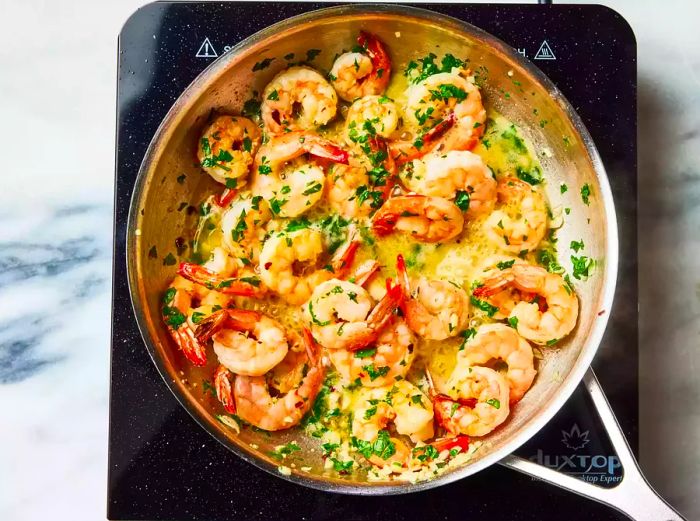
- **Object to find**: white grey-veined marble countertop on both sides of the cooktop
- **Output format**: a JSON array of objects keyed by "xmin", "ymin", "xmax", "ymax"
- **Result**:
[{"xmin": 0, "ymin": 0, "xmax": 700, "ymax": 521}]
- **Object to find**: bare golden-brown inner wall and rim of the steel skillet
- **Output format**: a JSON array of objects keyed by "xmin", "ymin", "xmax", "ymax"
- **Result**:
[{"xmin": 127, "ymin": 4, "xmax": 617, "ymax": 494}]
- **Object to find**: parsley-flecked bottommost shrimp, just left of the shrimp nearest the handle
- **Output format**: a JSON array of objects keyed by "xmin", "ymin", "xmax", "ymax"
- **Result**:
[{"xmin": 352, "ymin": 380, "xmax": 433, "ymax": 442}]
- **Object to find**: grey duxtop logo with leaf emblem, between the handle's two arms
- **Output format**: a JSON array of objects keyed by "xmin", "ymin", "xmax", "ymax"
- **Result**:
[{"xmin": 530, "ymin": 423, "xmax": 622, "ymax": 484}]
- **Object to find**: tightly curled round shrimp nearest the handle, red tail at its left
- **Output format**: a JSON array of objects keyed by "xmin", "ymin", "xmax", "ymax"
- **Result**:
[{"xmin": 432, "ymin": 366, "xmax": 510, "ymax": 436}]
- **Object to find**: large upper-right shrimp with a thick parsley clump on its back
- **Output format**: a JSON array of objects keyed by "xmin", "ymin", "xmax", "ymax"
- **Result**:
[{"xmin": 392, "ymin": 71, "xmax": 486, "ymax": 162}]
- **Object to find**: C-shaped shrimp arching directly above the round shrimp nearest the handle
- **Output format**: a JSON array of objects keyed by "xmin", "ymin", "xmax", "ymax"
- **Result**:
[{"xmin": 457, "ymin": 324, "xmax": 537, "ymax": 404}]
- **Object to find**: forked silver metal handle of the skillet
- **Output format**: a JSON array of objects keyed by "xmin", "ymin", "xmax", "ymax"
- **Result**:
[{"xmin": 499, "ymin": 369, "xmax": 685, "ymax": 521}]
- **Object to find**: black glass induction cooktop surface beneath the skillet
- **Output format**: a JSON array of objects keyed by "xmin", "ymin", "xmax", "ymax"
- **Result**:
[{"xmin": 108, "ymin": 2, "xmax": 638, "ymax": 521}]
